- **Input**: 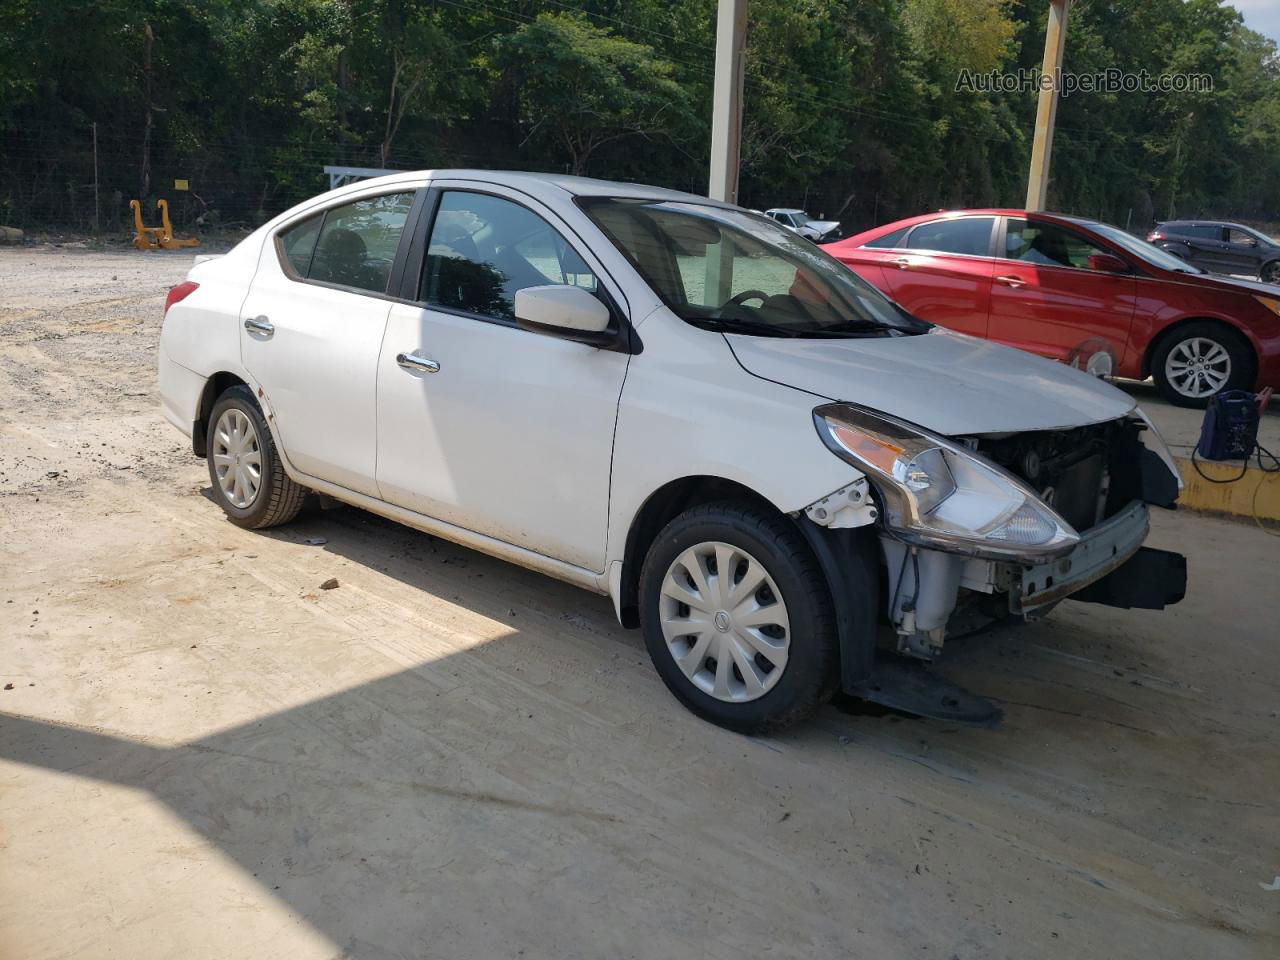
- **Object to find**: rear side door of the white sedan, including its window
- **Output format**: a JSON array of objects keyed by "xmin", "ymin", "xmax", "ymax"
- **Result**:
[{"xmin": 241, "ymin": 193, "xmax": 416, "ymax": 497}]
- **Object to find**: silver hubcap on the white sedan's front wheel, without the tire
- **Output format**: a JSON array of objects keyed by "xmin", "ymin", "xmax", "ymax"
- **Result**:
[{"xmin": 658, "ymin": 541, "xmax": 791, "ymax": 703}]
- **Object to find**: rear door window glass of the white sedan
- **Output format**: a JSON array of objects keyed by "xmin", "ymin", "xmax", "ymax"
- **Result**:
[{"xmin": 280, "ymin": 192, "xmax": 413, "ymax": 293}]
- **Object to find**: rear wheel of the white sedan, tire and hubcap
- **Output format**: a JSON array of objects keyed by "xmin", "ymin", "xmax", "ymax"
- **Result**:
[{"xmin": 207, "ymin": 387, "xmax": 307, "ymax": 530}]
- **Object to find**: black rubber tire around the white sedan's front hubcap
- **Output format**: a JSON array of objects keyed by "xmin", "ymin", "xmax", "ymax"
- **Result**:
[{"xmin": 640, "ymin": 502, "xmax": 838, "ymax": 735}]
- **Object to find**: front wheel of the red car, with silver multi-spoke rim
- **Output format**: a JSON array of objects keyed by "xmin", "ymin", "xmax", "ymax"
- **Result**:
[{"xmin": 1151, "ymin": 320, "xmax": 1253, "ymax": 407}]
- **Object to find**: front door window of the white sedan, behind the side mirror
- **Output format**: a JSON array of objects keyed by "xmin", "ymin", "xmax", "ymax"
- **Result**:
[{"xmin": 420, "ymin": 191, "xmax": 596, "ymax": 321}]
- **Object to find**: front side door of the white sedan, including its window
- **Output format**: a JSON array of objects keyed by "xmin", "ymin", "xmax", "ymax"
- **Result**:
[{"xmin": 378, "ymin": 188, "xmax": 628, "ymax": 572}]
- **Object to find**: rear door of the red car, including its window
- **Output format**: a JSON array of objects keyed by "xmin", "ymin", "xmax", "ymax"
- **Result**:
[{"xmin": 882, "ymin": 216, "xmax": 996, "ymax": 337}]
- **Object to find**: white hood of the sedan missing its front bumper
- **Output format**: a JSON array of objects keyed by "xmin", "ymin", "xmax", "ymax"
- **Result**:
[{"xmin": 726, "ymin": 328, "xmax": 1137, "ymax": 436}]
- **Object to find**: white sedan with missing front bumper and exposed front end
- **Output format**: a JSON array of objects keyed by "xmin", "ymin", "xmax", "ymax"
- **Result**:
[{"xmin": 160, "ymin": 170, "xmax": 1185, "ymax": 731}]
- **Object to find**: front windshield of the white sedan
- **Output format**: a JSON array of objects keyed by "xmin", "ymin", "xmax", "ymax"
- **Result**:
[{"xmin": 579, "ymin": 198, "xmax": 931, "ymax": 337}]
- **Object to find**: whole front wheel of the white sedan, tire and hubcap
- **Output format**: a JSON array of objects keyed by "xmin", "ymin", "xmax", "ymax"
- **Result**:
[{"xmin": 640, "ymin": 502, "xmax": 837, "ymax": 733}]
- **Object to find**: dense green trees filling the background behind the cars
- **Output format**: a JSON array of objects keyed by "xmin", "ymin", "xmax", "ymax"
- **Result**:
[{"xmin": 0, "ymin": 0, "xmax": 1280, "ymax": 229}]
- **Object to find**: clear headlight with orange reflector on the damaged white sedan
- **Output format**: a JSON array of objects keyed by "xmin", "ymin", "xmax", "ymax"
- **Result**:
[{"xmin": 813, "ymin": 403, "xmax": 1080, "ymax": 562}]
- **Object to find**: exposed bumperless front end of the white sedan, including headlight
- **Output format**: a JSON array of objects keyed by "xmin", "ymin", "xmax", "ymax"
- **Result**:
[{"xmin": 804, "ymin": 403, "xmax": 1187, "ymax": 723}]
